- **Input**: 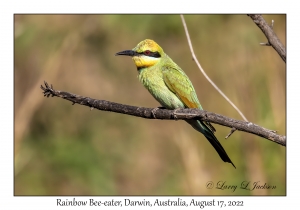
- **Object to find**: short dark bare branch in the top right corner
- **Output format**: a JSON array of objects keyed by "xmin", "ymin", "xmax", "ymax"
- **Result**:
[{"xmin": 248, "ymin": 14, "xmax": 286, "ymax": 62}]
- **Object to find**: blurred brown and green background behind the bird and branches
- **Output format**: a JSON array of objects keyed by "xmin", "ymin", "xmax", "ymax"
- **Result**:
[{"xmin": 14, "ymin": 15, "xmax": 286, "ymax": 195}]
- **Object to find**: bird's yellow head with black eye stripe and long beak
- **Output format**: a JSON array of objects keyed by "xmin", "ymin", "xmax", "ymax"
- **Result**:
[{"xmin": 116, "ymin": 39, "xmax": 164, "ymax": 69}]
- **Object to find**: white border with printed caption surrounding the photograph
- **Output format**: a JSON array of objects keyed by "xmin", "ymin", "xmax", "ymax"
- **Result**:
[{"xmin": 0, "ymin": 0, "xmax": 300, "ymax": 210}]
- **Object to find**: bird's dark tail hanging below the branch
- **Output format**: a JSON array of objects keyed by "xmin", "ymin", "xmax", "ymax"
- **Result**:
[{"xmin": 186, "ymin": 120, "xmax": 235, "ymax": 168}]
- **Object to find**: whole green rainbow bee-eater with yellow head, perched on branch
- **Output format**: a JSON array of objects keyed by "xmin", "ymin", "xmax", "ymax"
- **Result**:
[{"xmin": 116, "ymin": 39, "xmax": 235, "ymax": 167}]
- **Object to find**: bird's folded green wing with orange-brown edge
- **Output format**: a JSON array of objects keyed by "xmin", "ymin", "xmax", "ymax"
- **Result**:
[{"xmin": 162, "ymin": 65, "xmax": 202, "ymax": 109}]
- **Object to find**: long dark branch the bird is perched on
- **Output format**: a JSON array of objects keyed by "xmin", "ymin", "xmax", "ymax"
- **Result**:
[{"xmin": 41, "ymin": 82, "xmax": 286, "ymax": 146}]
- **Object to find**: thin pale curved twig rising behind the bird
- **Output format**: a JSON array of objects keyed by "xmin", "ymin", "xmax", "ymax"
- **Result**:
[{"xmin": 180, "ymin": 15, "xmax": 248, "ymax": 121}]
